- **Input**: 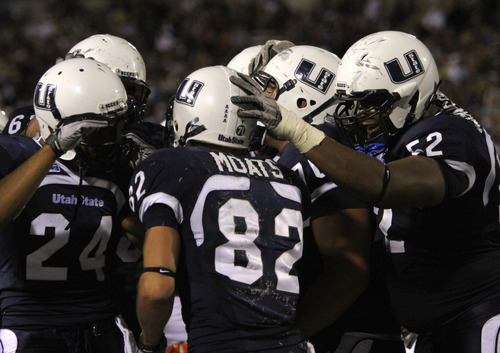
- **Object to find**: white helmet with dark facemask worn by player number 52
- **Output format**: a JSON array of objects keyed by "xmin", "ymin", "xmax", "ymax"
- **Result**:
[{"xmin": 335, "ymin": 31, "xmax": 439, "ymax": 146}]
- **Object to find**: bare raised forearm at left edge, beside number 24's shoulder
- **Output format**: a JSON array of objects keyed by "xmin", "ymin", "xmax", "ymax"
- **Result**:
[{"xmin": 0, "ymin": 146, "xmax": 56, "ymax": 228}]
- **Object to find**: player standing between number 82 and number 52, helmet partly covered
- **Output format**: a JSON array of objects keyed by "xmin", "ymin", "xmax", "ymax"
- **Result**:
[{"xmin": 248, "ymin": 46, "xmax": 404, "ymax": 353}]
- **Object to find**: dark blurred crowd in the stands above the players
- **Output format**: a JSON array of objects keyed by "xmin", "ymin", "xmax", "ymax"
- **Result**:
[{"xmin": 0, "ymin": 0, "xmax": 500, "ymax": 144}]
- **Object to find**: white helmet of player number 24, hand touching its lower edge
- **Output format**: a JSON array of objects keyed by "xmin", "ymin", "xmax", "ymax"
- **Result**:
[{"xmin": 33, "ymin": 58, "xmax": 127, "ymax": 159}]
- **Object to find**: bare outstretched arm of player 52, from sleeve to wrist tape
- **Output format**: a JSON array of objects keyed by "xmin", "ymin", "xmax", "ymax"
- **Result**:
[{"xmin": 304, "ymin": 138, "xmax": 446, "ymax": 208}]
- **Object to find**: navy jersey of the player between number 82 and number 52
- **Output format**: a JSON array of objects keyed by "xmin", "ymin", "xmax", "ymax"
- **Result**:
[{"xmin": 279, "ymin": 124, "xmax": 404, "ymax": 352}]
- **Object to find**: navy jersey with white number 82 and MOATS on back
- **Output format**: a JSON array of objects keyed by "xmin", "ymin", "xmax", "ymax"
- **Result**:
[{"xmin": 129, "ymin": 147, "xmax": 309, "ymax": 353}]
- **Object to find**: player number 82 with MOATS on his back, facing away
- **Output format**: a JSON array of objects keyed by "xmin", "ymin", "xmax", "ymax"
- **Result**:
[{"xmin": 129, "ymin": 66, "xmax": 309, "ymax": 353}]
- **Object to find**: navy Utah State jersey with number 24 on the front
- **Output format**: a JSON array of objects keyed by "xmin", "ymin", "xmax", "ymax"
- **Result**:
[{"xmin": 0, "ymin": 135, "xmax": 131, "ymax": 328}]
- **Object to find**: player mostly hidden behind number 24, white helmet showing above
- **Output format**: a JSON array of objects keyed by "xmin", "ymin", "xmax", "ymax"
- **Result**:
[{"xmin": 65, "ymin": 34, "xmax": 163, "ymax": 338}]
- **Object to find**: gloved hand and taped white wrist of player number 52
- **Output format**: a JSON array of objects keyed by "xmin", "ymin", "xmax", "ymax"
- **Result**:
[{"xmin": 229, "ymin": 73, "xmax": 325, "ymax": 153}]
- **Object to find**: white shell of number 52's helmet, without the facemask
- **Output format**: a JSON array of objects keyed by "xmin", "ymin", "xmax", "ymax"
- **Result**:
[{"xmin": 335, "ymin": 31, "xmax": 439, "ymax": 129}]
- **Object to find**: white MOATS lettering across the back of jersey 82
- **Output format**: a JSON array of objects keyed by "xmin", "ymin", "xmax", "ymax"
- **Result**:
[{"xmin": 210, "ymin": 152, "xmax": 283, "ymax": 179}]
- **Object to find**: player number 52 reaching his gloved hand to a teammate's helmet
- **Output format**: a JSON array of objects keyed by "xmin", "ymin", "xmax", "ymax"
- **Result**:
[{"xmin": 231, "ymin": 31, "xmax": 500, "ymax": 353}]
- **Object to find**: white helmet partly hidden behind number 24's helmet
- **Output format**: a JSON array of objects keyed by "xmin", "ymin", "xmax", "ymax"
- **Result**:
[{"xmin": 67, "ymin": 34, "xmax": 151, "ymax": 119}]
